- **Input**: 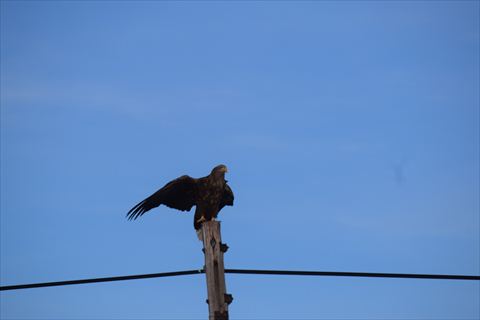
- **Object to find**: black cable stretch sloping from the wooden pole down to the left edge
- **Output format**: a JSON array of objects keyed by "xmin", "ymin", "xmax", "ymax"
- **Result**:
[{"xmin": 0, "ymin": 269, "xmax": 205, "ymax": 291}]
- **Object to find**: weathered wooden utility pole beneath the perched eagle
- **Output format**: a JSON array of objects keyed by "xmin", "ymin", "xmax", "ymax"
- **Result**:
[{"xmin": 202, "ymin": 221, "xmax": 233, "ymax": 320}]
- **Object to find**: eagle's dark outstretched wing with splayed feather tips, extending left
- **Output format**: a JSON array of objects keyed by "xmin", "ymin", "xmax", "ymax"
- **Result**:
[{"xmin": 127, "ymin": 176, "xmax": 197, "ymax": 220}]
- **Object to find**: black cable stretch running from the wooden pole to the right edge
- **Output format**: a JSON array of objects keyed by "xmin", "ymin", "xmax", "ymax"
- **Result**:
[{"xmin": 225, "ymin": 269, "xmax": 480, "ymax": 280}]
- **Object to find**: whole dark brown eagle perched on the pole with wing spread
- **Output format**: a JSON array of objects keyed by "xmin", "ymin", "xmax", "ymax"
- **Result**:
[{"xmin": 127, "ymin": 164, "xmax": 234, "ymax": 233}]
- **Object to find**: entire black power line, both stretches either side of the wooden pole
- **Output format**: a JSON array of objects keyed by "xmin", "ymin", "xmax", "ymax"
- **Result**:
[{"xmin": 0, "ymin": 269, "xmax": 480, "ymax": 291}]
